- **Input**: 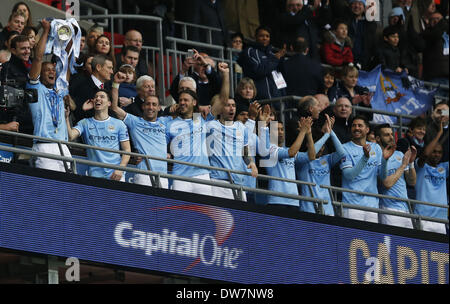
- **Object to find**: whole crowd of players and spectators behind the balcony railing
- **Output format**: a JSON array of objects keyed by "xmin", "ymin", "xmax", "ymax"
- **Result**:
[{"xmin": 0, "ymin": 0, "xmax": 449, "ymax": 233}]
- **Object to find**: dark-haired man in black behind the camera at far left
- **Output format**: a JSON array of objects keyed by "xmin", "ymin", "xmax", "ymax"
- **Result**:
[{"xmin": 0, "ymin": 35, "xmax": 33, "ymax": 133}]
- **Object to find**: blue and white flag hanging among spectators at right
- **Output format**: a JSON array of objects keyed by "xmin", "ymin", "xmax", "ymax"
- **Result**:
[{"xmin": 358, "ymin": 65, "xmax": 436, "ymax": 124}]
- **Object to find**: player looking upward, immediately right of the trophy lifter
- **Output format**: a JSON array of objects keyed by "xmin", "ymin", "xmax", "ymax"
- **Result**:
[{"xmin": 66, "ymin": 89, "xmax": 131, "ymax": 182}]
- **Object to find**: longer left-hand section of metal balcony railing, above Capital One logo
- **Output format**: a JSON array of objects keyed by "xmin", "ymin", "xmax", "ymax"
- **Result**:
[{"xmin": 0, "ymin": 130, "xmax": 328, "ymax": 213}]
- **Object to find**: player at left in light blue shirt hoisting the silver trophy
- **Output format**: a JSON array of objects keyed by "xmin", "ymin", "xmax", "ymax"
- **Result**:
[{"xmin": 27, "ymin": 19, "xmax": 71, "ymax": 172}]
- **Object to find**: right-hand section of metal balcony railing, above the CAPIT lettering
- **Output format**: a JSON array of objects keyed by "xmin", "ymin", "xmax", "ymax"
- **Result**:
[{"xmin": 320, "ymin": 185, "xmax": 449, "ymax": 230}]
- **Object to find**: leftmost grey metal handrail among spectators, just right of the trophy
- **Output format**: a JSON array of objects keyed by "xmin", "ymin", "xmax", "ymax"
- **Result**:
[{"xmin": 80, "ymin": 14, "xmax": 166, "ymax": 101}]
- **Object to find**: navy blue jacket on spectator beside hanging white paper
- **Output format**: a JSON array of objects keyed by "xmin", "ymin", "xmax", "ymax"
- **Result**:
[{"xmin": 237, "ymin": 44, "xmax": 285, "ymax": 100}]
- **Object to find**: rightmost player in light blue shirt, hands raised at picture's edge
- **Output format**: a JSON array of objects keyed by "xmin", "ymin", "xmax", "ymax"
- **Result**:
[{"xmin": 414, "ymin": 123, "xmax": 449, "ymax": 234}]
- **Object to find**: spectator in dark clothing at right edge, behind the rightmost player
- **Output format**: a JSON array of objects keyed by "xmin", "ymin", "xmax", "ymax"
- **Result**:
[{"xmin": 425, "ymin": 101, "xmax": 449, "ymax": 162}]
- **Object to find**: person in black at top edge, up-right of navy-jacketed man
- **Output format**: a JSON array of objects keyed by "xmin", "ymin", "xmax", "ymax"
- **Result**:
[{"xmin": 279, "ymin": 0, "xmax": 320, "ymax": 62}]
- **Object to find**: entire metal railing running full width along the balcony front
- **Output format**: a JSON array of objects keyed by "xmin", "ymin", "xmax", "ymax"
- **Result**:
[{"xmin": 0, "ymin": 130, "xmax": 448, "ymax": 230}]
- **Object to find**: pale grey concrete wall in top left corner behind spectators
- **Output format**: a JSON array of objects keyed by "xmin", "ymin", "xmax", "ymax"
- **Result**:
[{"xmin": 0, "ymin": 0, "xmax": 93, "ymax": 30}]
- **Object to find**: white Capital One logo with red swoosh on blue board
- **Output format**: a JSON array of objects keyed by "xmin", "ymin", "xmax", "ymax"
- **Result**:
[{"xmin": 114, "ymin": 205, "xmax": 243, "ymax": 272}]
